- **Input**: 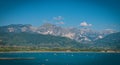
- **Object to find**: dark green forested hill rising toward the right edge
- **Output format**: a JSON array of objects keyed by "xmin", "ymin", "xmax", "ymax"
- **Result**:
[{"xmin": 94, "ymin": 32, "xmax": 120, "ymax": 50}]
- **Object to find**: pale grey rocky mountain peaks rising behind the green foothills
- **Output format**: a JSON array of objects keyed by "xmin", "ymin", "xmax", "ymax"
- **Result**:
[{"xmin": 0, "ymin": 23, "xmax": 115, "ymax": 42}]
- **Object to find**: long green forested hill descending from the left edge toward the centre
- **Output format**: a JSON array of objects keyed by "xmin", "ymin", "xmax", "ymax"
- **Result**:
[{"xmin": 0, "ymin": 33, "xmax": 80, "ymax": 48}]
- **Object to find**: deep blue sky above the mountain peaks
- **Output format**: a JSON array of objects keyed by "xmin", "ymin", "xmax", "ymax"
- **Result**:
[{"xmin": 0, "ymin": 0, "xmax": 120, "ymax": 30}]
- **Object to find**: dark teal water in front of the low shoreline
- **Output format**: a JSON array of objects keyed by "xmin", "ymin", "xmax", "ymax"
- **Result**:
[{"xmin": 0, "ymin": 52, "xmax": 120, "ymax": 65}]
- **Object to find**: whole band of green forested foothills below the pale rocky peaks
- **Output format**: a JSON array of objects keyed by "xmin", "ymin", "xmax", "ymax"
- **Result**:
[{"xmin": 0, "ymin": 32, "xmax": 120, "ymax": 51}]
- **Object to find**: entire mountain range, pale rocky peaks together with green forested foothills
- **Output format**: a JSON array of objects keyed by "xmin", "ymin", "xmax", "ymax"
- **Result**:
[{"xmin": 0, "ymin": 23, "xmax": 120, "ymax": 50}]
